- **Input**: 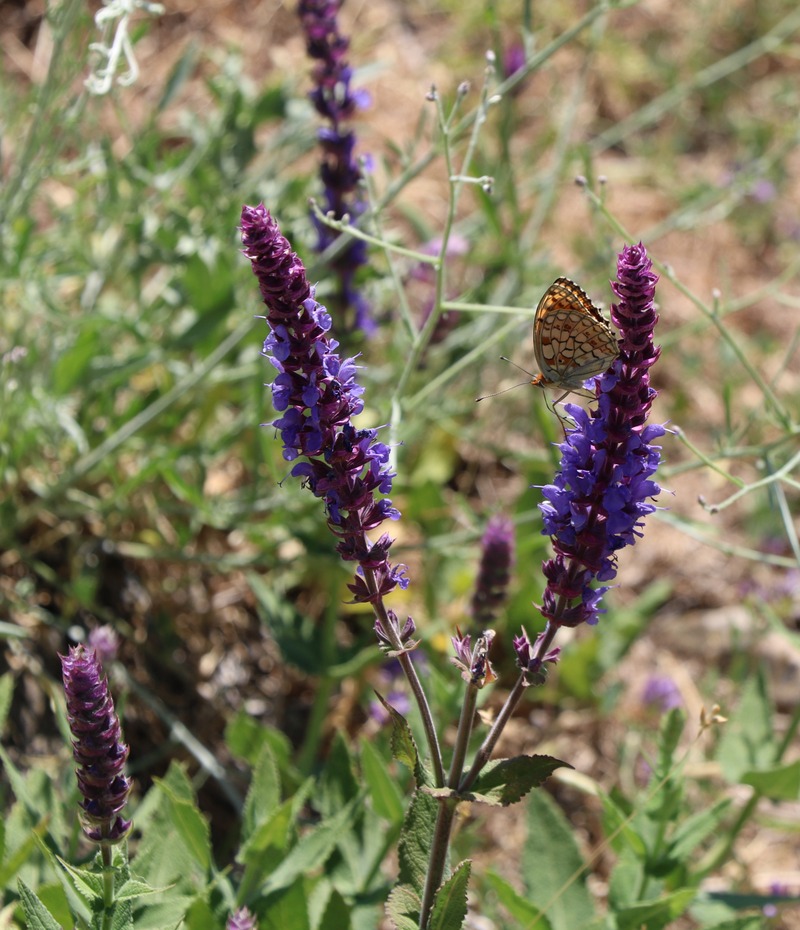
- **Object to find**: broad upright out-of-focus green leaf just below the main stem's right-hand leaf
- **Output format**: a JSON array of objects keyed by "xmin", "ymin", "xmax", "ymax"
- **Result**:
[{"xmin": 522, "ymin": 791, "xmax": 595, "ymax": 930}]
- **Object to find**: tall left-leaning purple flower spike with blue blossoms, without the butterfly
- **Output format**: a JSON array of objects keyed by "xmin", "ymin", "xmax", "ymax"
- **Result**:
[{"xmin": 242, "ymin": 204, "xmax": 408, "ymax": 602}]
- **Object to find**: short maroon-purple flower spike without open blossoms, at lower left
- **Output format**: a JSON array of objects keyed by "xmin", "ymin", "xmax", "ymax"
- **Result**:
[{"xmin": 60, "ymin": 646, "xmax": 131, "ymax": 843}]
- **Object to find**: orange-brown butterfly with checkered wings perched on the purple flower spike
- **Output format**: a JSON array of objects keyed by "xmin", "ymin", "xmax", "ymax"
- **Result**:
[{"xmin": 531, "ymin": 278, "xmax": 619, "ymax": 403}]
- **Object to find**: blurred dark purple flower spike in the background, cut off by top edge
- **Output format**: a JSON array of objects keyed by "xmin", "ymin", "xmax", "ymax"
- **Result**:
[{"xmin": 298, "ymin": 0, "xmax": 375, "ymax": 333}]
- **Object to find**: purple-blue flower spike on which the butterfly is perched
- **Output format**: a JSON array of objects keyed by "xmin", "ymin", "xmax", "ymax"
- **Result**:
[{"xmin": 539, "ymin": 243, "xmax": 666, "ymax": 626}]
